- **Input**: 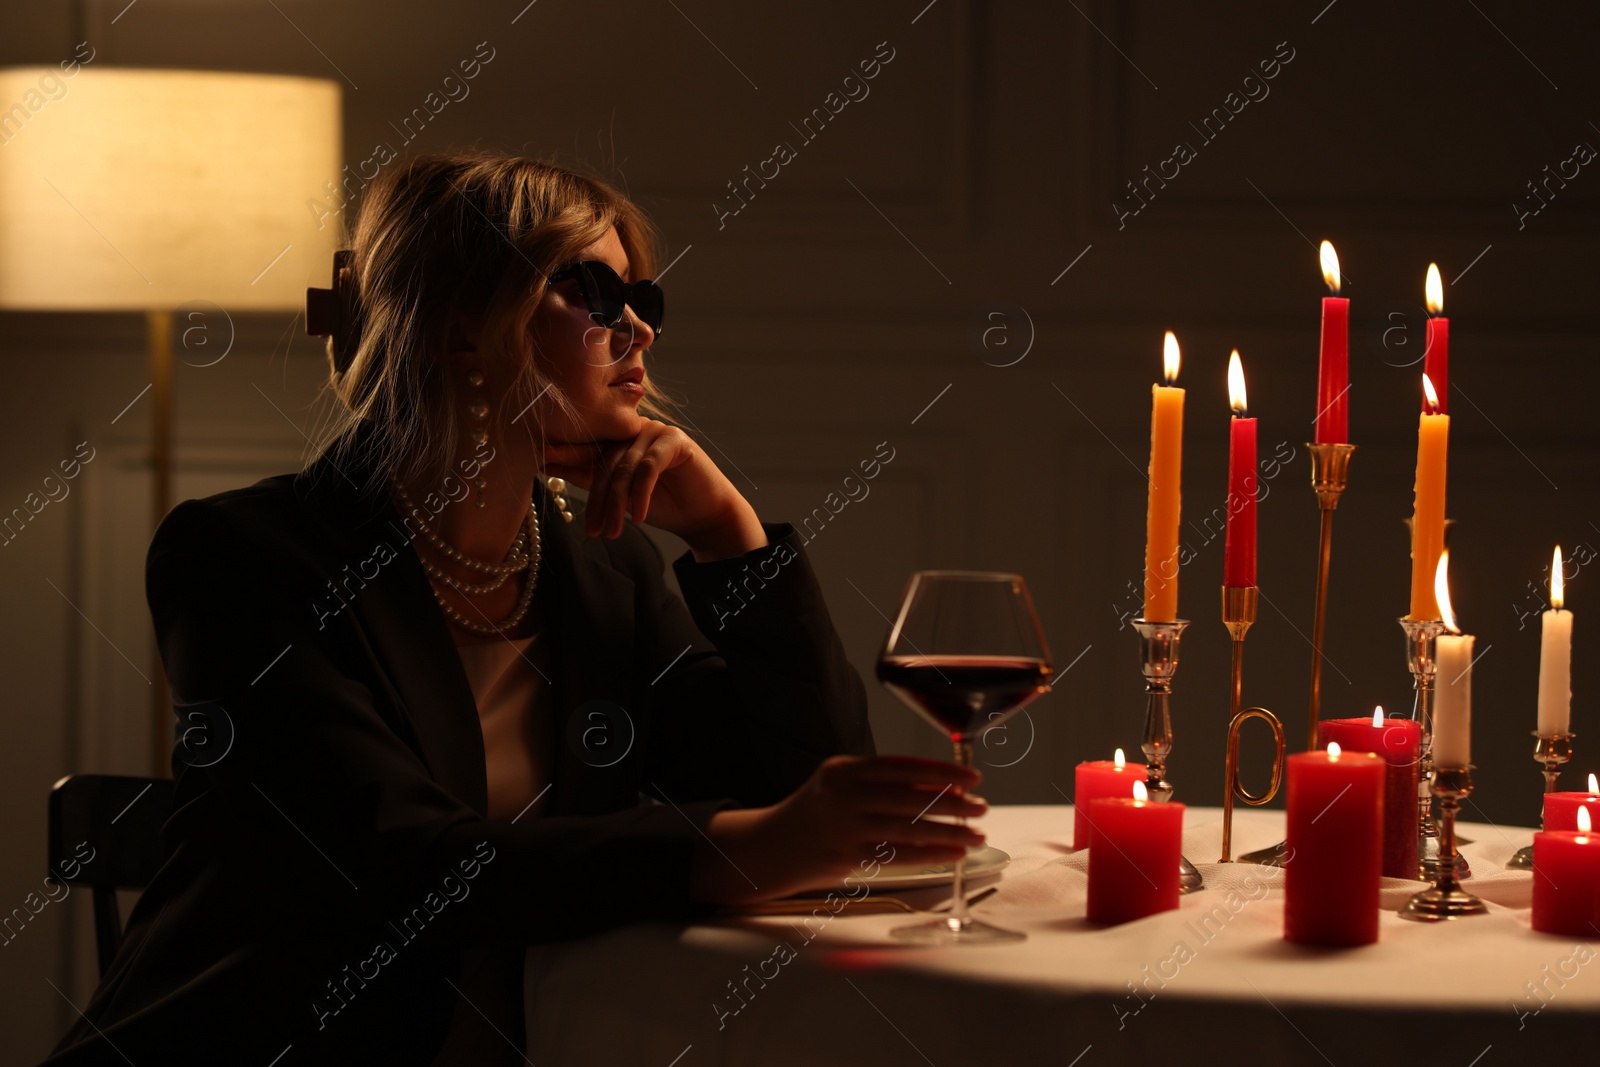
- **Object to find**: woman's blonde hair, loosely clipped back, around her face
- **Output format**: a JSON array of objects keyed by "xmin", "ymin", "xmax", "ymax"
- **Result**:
[{"xmin": 323, "ymin": 152, "xmax": 675, "ymax": 486}]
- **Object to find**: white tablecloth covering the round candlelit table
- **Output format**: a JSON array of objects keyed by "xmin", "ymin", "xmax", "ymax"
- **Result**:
[{"xmin": 526, "ymin": 806, "xmax": 1600, "ymax": 1067}]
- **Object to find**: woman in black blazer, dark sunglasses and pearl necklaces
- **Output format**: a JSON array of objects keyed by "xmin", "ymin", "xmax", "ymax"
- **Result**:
[{"xmin": 48, "ymin": 155, "xmax": 984, "ymax": 1067}]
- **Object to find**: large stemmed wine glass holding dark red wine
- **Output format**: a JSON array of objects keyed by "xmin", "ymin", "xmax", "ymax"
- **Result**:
[{"xmin": 877, "ymin": 571, "xmax": 1051, "ymax": 944}]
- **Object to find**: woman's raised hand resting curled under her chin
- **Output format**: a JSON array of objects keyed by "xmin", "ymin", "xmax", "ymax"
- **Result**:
[{"xmin": 542, "ymin": 418, "xmax": 766, "ymax": 561}]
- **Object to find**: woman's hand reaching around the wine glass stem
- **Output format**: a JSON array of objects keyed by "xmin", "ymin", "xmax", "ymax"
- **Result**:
[{"xmin": 691, "ymin": 755, "xmax": 989, "ymax": 904}]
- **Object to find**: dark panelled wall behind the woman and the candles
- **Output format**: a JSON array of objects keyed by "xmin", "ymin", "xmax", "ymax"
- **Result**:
[{"xmin": 0, "ymin": 0, "xmax": 1600, "ymax": 1062}]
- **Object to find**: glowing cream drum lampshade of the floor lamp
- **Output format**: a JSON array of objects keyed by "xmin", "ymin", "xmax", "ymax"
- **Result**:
[{"xmin": 0, "ymin": 67, "xmax": 342, "ymax": 312}]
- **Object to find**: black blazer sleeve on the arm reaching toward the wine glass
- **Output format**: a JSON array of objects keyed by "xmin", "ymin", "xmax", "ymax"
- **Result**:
[{"xmin": 146, "ymin": 501, "xmax": 730, "ymax": 947}]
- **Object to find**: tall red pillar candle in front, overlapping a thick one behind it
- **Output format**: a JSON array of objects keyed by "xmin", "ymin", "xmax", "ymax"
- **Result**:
[{"xmin": 1283, "ymin": 744, "xmax": 1382, "ymax": 945}]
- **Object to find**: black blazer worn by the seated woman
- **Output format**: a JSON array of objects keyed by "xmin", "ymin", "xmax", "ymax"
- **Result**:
[{"xmin": 46, "ymin": 428, "xmax": 872, "ymax": 1067}]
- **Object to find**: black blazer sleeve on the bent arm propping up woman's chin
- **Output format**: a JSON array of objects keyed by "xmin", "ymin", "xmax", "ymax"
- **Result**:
[{"xmin": 633, "ymin": 523, "xmax": 875, "ymax": 806}]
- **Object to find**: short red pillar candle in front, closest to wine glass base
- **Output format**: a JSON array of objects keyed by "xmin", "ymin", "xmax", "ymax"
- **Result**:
[{"xmin": 1088, "ymin": 782, "xmax": 1184, "ymax": 923}]
